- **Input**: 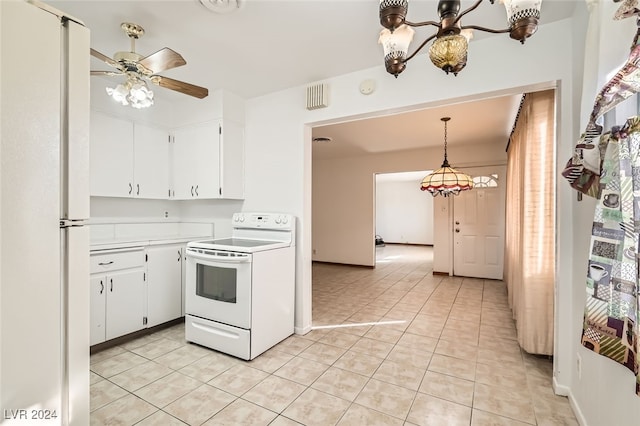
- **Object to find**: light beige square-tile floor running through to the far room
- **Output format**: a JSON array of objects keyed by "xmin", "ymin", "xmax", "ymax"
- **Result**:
[{"xmin": 91, "ymin": 245, "xmax": 578, "ymax": 426}]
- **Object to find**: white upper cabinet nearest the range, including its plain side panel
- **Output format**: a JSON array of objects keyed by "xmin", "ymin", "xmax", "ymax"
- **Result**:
[{"xmin": 172, "ymin": 120, "xmax": 244, "ymax": 200}]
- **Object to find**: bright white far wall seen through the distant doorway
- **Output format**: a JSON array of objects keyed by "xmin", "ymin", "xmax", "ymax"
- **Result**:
[{"xmin": 375, "ymin": 176, "xmax": 433, "ymax": 245}]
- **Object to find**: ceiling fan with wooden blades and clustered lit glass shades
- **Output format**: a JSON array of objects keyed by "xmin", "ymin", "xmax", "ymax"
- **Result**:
[{"xmin": 91, "ymin": 22, "xmax": 209, "ymax": 108}]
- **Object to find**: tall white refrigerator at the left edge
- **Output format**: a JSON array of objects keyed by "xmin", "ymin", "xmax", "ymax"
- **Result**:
[{"xmin": 0, "ymin": 0, "xmax": 89, "ymax": 426}]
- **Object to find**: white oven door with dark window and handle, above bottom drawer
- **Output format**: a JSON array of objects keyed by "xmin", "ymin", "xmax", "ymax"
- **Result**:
[{"xmin": 185, "ymin": 248, "xmax": 251, "ymax": 329}]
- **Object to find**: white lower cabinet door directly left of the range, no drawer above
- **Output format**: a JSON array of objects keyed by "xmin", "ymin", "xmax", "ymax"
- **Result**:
[{"xmin": 147, "ymin": 245, "xmax": 182, "ymax": 327}]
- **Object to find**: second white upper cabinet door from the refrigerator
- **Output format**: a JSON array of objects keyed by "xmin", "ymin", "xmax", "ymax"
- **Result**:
[{"xmin": 133, "ymin": 123, "xmax": 169, "ymax": 199}]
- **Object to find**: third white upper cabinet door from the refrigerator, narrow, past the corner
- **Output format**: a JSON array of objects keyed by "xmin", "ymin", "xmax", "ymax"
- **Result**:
[{"xmin": 171, "ymin": 126, "xmax": 198, "ymax": 200}]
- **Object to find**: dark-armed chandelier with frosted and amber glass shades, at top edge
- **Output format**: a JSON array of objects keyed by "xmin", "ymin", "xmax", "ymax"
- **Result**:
[{"xmin": 378, "ymin": 0, "xmax": 542, "ymax": 78}]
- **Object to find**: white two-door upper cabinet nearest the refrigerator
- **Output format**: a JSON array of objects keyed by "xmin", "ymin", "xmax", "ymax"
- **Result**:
[{"xmin": 90, "ymin": 111, "xmax": 169, "ymax": 199}]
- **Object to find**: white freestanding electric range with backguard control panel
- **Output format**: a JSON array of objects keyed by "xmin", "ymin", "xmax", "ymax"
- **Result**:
[{"xmin": 185, "ymin": 213, "xmax": 295, "ymax": 360}]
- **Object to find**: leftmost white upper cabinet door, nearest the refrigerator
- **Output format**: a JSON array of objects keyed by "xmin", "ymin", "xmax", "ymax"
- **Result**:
[{"xmin": 89, "ymin": 112, "xmax": 134, "ymax": 197}]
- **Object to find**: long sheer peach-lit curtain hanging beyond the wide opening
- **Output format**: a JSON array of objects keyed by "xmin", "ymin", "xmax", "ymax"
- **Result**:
[{"xmin": 505, "ymin": 90, "xmax": 556, "ymax": 355}]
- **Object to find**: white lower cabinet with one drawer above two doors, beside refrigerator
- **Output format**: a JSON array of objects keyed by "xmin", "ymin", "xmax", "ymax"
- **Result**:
[{"xmin": 90, "ymin": 247, "xmax": 147, "ymax": 345}]
